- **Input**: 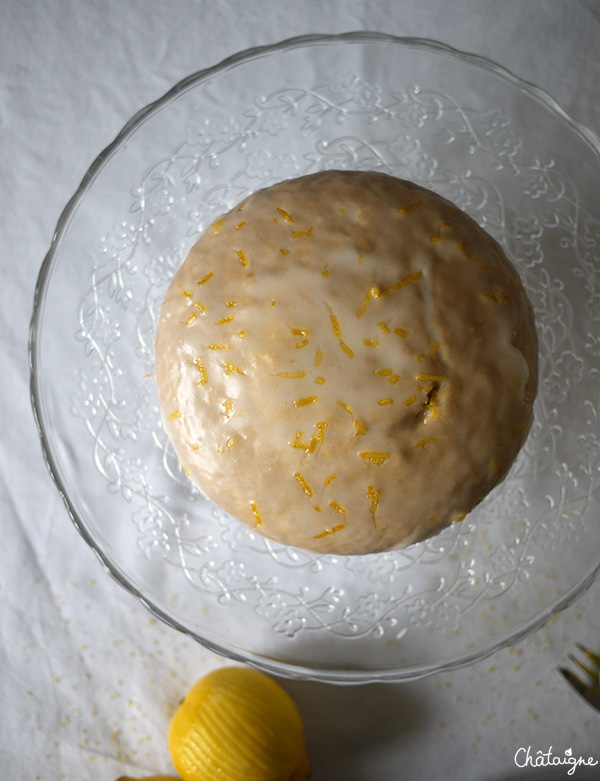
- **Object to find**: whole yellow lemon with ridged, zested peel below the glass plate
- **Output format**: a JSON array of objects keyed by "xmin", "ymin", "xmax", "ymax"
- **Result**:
[{"xmin": 169, "ymin": 667, "xmax": 310, "ymax": 781}]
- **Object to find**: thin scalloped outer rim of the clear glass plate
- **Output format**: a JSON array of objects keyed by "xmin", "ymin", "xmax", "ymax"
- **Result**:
[{"xmin": 29, "ymin": 32, "xmax": 600, "ymax": 684}]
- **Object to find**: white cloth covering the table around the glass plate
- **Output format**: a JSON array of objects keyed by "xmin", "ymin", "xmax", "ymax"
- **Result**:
[{"xmin": 0, "ymin": 0, "xmax": 600, "ymax": 781}]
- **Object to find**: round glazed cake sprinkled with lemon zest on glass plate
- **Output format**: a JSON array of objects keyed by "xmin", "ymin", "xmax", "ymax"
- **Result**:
[{"xmin": 155, "ymin": 171, "xmax": 537, "ymax": 554}]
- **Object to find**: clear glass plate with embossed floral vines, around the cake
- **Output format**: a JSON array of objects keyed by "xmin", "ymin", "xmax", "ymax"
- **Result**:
[{"xmin": 30, "ymin": 33, "xmax": 600, "ymax": 683}]
